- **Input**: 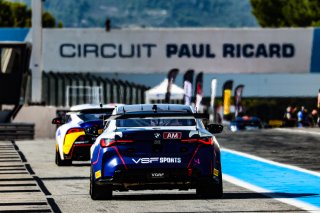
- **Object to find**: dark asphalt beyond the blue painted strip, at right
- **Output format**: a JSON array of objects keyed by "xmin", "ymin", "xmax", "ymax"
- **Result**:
[{"xmin": 217, "ymin": 128, "xmax": 320, "ymax": 172}]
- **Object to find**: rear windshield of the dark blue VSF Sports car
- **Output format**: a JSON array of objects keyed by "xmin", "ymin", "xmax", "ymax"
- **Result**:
[{"xmin": 116, "ymin": 118, "xmax": 196, "ymax": 127}]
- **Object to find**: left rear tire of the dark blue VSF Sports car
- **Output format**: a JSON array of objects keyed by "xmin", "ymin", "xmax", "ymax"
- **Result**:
[{"xmin": 89, "ymin": 168, "xmax": 112, "ymax": 200}]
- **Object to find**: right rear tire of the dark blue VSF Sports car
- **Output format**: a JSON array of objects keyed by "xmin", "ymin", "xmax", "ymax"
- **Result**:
[{"xmin": 196, "ymin": 173, "xmax": 223, "ymax": 199}]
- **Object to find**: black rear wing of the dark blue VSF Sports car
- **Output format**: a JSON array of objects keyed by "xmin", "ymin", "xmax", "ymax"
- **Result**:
[{"xmin": 107, "ymin": 112, "xmax": 209, "ymax": 121}]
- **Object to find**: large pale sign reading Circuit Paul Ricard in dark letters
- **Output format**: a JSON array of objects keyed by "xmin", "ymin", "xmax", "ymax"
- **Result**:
[{"xmin": 43, "ymin": 28, "xmax": 313, "ymax": 73}]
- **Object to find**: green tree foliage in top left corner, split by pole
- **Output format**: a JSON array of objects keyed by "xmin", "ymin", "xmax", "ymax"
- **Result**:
[{"xmin": 0, "ymin": 0, "xmax": 63, "ymax": 27}]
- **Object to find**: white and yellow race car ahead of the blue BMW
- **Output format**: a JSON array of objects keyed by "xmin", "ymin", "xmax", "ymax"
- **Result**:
[{"xmin": 52, "ymin": 104, "xmax": 115, "ymax": 166}]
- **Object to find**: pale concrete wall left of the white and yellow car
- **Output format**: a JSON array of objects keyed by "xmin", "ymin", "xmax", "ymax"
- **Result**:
[{"xmin": 13, "ymin": 106, "xmax": 57, "ymax": 139}]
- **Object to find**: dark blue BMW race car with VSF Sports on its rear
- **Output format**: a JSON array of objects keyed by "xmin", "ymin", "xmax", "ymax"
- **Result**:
[{"xmin": 90, "ymin": 104, "xmax": 223, "ymax": 200}]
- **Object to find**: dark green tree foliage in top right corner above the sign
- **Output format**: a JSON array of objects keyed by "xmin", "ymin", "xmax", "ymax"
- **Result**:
[{"xmin": 250, "ymin": 0, "xmax": 320, "ymax": 27}]
